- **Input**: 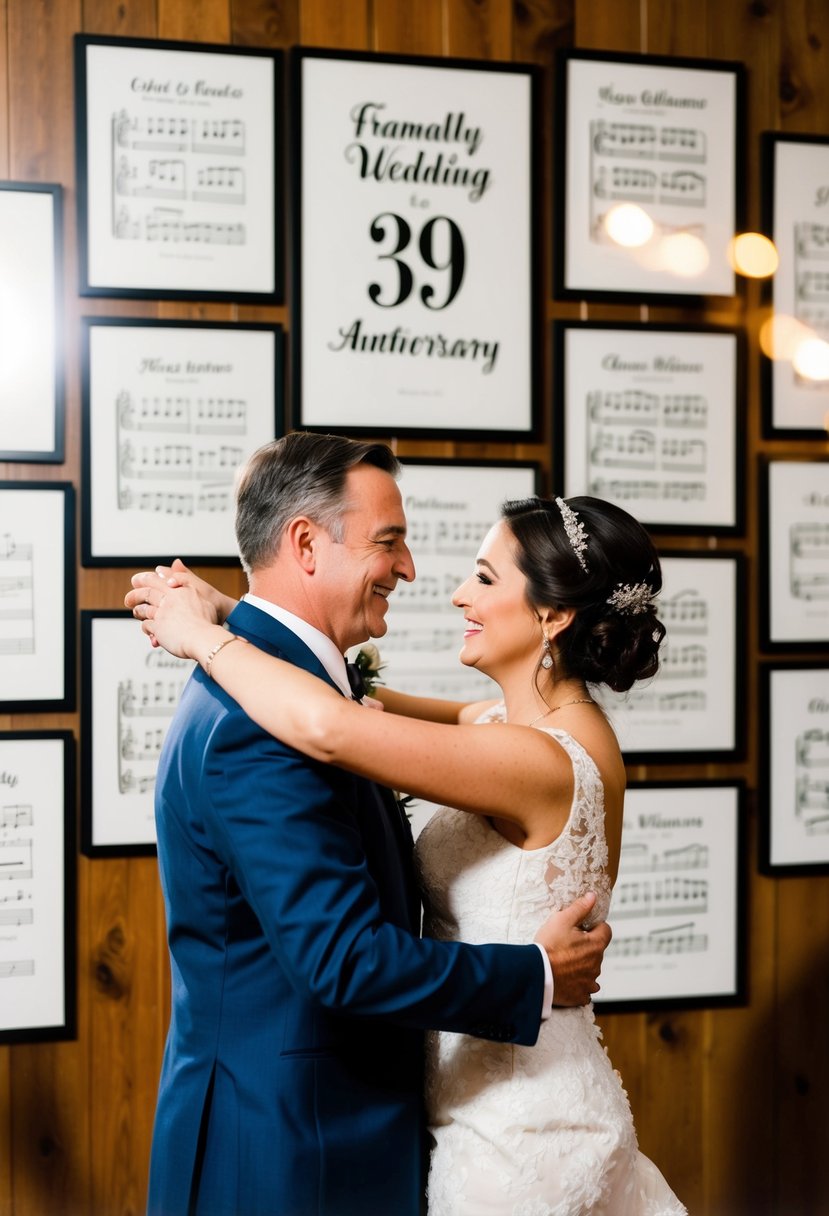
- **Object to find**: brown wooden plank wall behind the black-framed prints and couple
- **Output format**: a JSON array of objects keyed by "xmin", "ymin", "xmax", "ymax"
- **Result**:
[{"xmin": 0, "ymin": 0, "xmax": 829, "ymax": 1216}]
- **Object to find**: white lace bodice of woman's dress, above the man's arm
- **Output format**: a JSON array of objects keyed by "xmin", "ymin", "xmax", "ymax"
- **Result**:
[{"xmin": 417, "ymin": 704, "xmax": 610, "ymax": 942}]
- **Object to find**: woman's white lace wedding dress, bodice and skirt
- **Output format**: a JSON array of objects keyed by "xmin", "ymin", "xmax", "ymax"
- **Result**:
[{"xmin": 417, "ymin": 706, "xmax": 686, "ymax": 1216}]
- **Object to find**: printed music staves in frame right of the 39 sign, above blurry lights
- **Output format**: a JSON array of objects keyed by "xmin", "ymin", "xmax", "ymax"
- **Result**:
[{"xmin": 590, "ymin": 118, "xmax": 707, "ymax": 244}]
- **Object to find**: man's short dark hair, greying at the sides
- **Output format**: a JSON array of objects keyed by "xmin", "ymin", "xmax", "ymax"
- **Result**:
[{"xmin": 236, "ymin": 430, "xmax": 400, "ymax": 575}]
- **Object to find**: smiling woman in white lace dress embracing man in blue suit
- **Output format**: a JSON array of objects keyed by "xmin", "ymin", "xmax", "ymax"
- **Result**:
[{"xmin": 126, "ymin": 497, "xmax": 686, "ymax": 1216}]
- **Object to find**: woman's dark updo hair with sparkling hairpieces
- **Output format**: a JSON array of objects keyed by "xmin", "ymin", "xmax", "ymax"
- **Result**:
[{"xmin": 501, "ymin": 496, "xmax": 665, "ymax": 692}]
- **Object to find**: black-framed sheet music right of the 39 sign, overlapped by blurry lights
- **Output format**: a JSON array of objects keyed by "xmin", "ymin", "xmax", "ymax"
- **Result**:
[{"xmin": 553, "ymin": 50, "xmax": 745, "ymax": 305}]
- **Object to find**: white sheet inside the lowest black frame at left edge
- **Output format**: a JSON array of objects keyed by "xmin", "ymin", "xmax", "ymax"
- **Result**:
[{"xmin": 0, "ymin": 738, "xmax": 64, "ymax": 1030}]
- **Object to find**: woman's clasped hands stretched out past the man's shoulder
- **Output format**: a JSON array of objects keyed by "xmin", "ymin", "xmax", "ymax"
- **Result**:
[{"xmin": 124, "ymin": 567, "xmax": 227, "ymax": 659}]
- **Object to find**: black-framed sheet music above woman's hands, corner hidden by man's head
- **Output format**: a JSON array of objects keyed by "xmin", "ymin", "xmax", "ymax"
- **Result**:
[{"xmin": 81, "ymin": 317, "xmax": 283, "ymax": 565}]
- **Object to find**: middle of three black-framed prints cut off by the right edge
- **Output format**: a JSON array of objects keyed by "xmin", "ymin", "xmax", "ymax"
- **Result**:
[{"xmin": 760, "ymin": 460, "xmax": 829, "ymax": 651}]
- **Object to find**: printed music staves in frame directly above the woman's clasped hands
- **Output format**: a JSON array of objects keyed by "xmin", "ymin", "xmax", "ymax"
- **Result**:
[{"xmin": 114, "ymin": 388, "xmax": 248, "ymax": 517}]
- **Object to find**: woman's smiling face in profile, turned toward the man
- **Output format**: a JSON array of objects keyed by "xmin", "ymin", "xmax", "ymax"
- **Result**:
[{"xmin": 452, "ymin": 520, "xmax": 543, "ymax": 680}]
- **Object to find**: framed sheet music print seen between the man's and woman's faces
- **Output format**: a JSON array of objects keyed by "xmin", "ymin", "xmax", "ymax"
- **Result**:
[{"xmin": 362, "ymin": 458, "xmax": 540, "ymax": 833}]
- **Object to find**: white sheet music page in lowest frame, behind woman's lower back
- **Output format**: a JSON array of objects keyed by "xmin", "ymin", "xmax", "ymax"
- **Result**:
[{"xmin": 599, "ymin": 788, "xmax": 734, "ymax": 1001}]
